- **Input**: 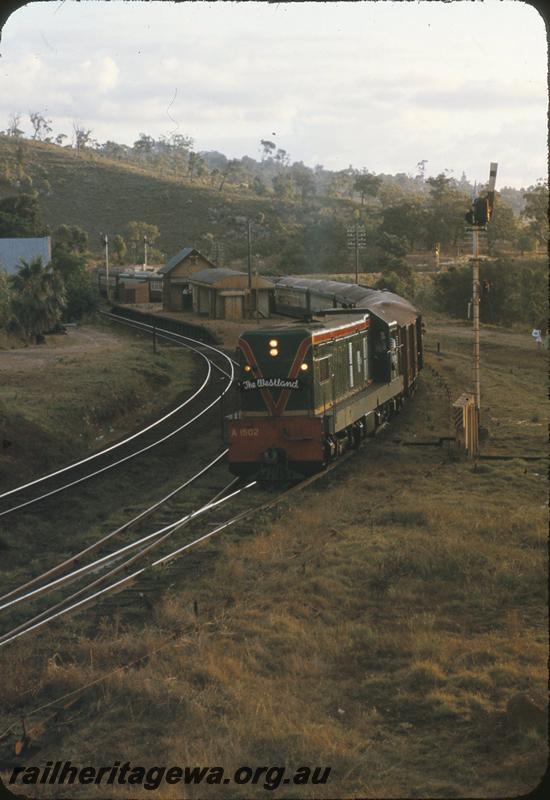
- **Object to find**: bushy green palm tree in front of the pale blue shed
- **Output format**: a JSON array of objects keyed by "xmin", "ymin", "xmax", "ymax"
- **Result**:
[{"xmin": 11, "ymin": 256, "xmax": 66, "ymax": 341}]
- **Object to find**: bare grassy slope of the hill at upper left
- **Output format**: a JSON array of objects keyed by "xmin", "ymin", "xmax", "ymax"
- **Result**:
[{"xmin": 0, "ymin": 136, "xmax": 354, "ymax": 268}]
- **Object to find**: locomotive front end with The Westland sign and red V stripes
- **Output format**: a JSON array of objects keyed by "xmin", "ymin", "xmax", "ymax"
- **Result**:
[{"xmin": 228, "ymin": 328, "xmax": 324, "ymax": 480}]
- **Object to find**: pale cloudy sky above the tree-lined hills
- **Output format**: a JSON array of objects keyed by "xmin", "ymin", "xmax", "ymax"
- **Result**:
[{"xmin": 0, "ymin": 0, "xmax": 548, "ymax": 189}]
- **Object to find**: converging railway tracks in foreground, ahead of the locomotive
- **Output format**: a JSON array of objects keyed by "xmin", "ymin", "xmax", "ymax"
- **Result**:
[{"xmin": 0, "ymin": 452, "xmax": 358, "ymax": 653}]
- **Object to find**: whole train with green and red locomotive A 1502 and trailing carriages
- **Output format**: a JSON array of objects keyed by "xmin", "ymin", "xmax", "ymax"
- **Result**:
[{"xmin": 227, "ymin": 277, "xmax": 423, "ymax": 481}]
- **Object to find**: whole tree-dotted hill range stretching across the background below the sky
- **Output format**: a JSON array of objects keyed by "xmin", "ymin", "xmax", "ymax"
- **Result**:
[{"xmin": 0, "ymin": 132, "xmax": 548, "ymax": 275}]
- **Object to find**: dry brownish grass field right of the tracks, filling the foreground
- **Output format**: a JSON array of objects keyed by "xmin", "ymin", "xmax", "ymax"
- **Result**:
[{"xmin": 0, "ymin": 318, "xmax": 548, "ymax": 800}]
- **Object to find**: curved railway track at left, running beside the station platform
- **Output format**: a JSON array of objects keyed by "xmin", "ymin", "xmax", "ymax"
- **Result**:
[{"xmin": 0, "ymin": 314, "xmax": 235, "ymax": 519}]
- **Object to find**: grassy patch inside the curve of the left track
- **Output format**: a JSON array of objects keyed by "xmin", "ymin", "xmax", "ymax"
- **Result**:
[{"xmin": 0, "ymin": 324, "xmax": 194, "ymax": 490}]
